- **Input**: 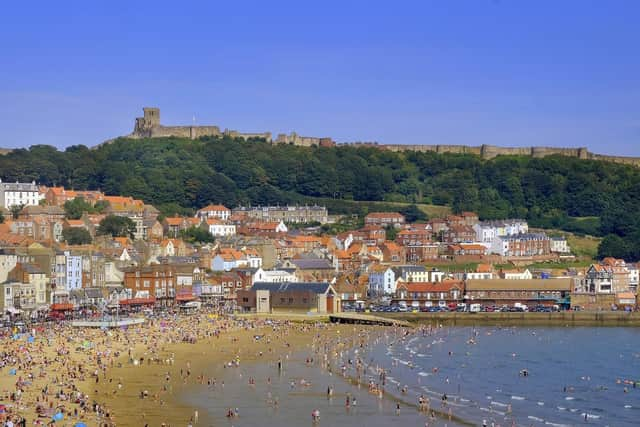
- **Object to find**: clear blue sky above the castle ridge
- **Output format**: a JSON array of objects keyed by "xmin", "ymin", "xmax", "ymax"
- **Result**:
[{"xmin": 0, "ymin": 0, "xmax": 640, "ymax": 156}]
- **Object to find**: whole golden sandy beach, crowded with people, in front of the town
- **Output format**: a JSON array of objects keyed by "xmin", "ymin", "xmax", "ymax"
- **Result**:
[{"xmin": 0, "ymin": 313, "xmax": 364, "ymax": 426}]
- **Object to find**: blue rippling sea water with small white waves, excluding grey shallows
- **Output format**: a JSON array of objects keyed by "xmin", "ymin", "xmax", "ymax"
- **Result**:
[{"xmin": 373, "ymin": 327, "xmax": 640, "ymax": 427}]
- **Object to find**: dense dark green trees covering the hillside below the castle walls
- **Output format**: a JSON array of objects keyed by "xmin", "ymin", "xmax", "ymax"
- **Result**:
[{"xmin": 0, "ymin": 138, "xmax": 640, "ymax": 258}]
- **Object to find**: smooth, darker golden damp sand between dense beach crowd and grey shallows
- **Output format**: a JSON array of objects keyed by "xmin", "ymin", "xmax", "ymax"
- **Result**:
[{"xmin": 94, "ymin": 319, "xmax": 356, "ymax": 426}]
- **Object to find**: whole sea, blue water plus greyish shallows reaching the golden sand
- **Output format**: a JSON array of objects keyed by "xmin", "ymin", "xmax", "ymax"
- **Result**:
[{"xmin": 181, "ymin": 326, "xmax": 640, "ymax": 427}]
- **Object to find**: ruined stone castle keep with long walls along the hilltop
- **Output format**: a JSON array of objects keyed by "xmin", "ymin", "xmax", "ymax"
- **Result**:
[{"xmin": 127, "ymin": 107, "xmax": 640, "ymax": 166}]
